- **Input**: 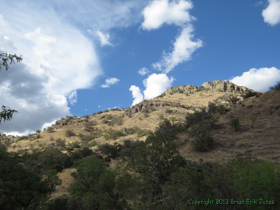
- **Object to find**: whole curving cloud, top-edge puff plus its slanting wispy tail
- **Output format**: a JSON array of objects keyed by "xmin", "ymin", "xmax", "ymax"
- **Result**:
[{"xmin": 142, "ymin": 0, "xmax": 202, "ymax": 74}]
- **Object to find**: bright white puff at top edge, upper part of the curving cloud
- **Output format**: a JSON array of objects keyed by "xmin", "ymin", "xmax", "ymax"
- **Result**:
[{"xmin": 142, "ymin": 0, "xmax": 193, "ymax": 30}]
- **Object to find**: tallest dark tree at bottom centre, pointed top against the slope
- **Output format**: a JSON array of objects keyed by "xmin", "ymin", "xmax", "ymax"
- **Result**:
[{"xmin": 129, "ymin": 120, "xmax": 185, "ymax": 208}]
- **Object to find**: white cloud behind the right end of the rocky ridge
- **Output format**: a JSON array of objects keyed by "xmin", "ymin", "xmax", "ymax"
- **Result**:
[{"xmin": 230, "ymin": 67, "xmax": 280, "ymax": 91}]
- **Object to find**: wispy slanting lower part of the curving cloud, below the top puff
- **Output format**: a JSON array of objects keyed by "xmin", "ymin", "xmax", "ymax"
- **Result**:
[{"xmin": 153, "ymin": 25, "xmax": 203, "ymax": 73}]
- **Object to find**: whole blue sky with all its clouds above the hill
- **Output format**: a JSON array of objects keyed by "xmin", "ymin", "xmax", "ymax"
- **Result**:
[{"xmin": 0, "ymin": 0, "xmax": 280, "ymax": 134}]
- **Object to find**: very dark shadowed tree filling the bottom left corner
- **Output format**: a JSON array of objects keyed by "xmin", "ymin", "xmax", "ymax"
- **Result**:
[{"xmin": 0, "ymin": 145, "xmax": 52, "ymax": 210}]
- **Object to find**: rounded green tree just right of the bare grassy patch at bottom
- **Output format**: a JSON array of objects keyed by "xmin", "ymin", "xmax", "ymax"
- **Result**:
[{"xmin": 68, "ymin": 156, "xmax": 118, "ymax": 209}]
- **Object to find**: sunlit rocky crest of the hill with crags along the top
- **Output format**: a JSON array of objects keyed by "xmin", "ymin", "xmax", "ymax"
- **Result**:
[{"xmin": 125, "ymin": 80, "xmax": 256, "ymax": 116}]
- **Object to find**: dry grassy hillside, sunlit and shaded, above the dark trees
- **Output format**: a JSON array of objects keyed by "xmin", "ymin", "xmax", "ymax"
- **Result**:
[{"xmin": 1, "ymin": 80, "xmax": 280, "ymax": 164}]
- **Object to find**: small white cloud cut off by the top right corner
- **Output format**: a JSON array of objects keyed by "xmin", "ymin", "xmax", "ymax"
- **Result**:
[{"xmin": 262, "ymin": 0, "xmax": 280, "ymax": 26}]
